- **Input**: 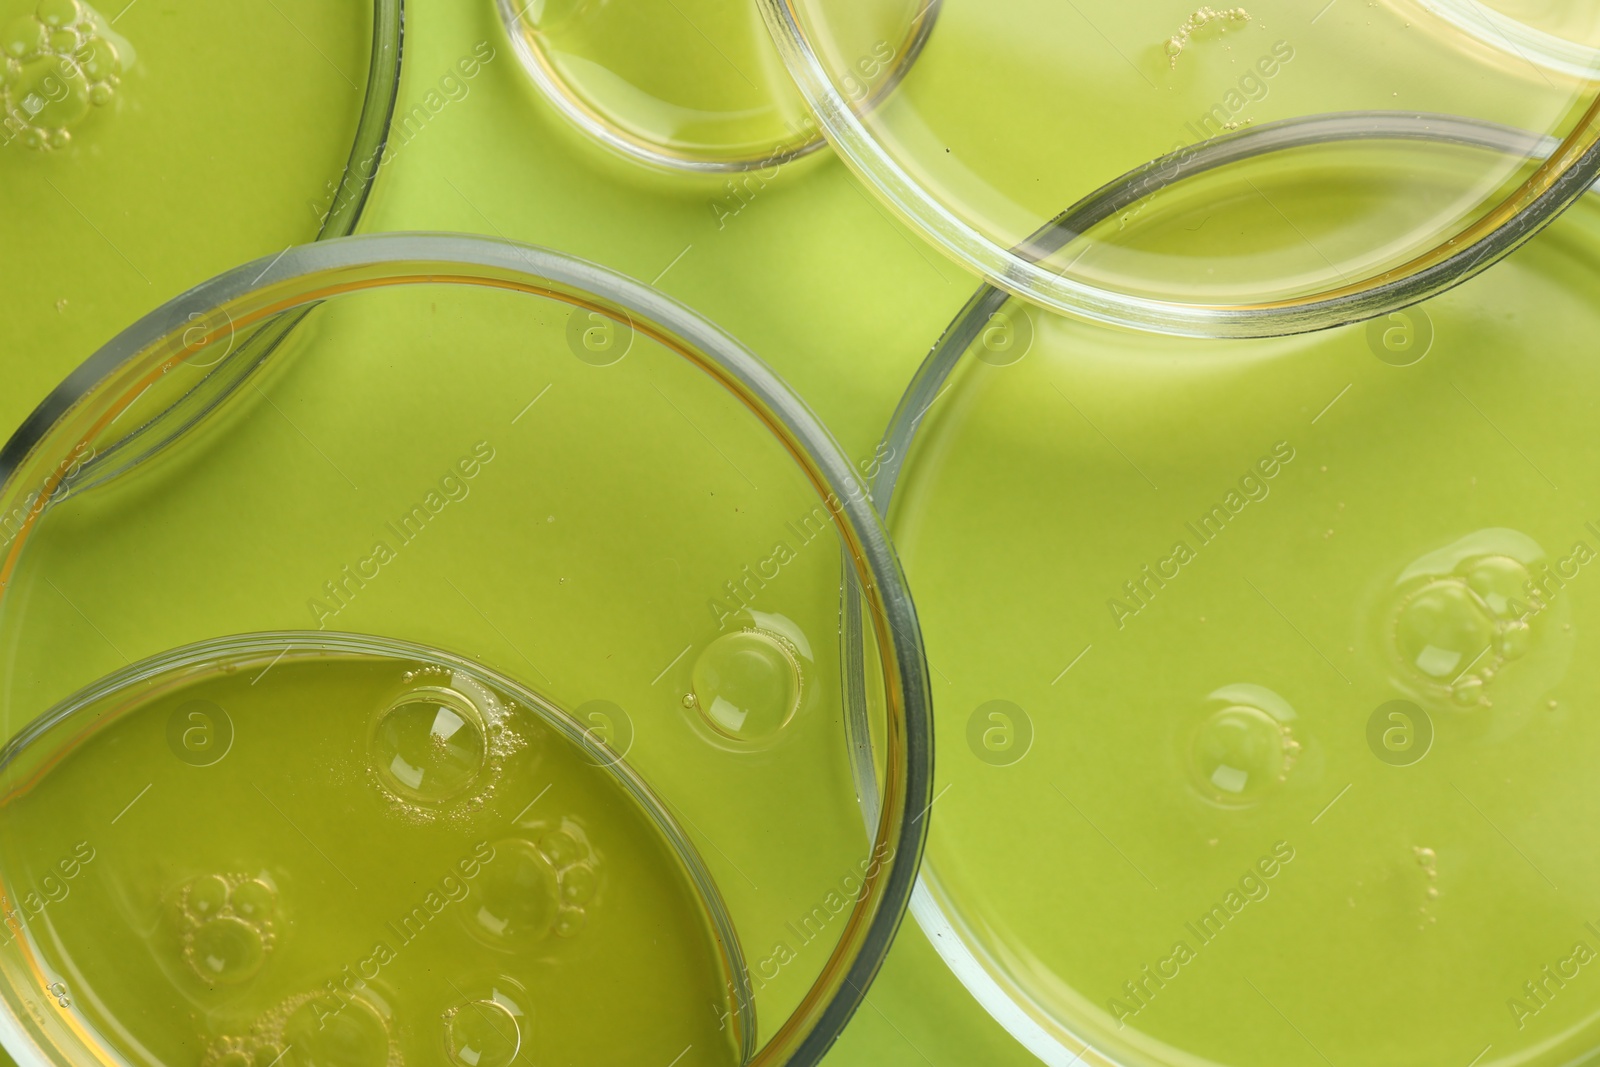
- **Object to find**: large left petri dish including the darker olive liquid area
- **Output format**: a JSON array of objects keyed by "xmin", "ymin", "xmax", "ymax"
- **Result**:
[{"xmin": 0, "ymin": 234, "xmax": 931, "ymax": 1067}]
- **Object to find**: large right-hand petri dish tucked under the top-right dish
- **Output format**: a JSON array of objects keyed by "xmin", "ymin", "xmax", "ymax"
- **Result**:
[{"xmin": 875, "ymin": 116, "xmax": 1600, "ymax": 1067}]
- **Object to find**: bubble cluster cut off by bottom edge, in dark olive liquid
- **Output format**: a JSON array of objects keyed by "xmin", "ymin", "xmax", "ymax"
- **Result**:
[{"xmin": 200, "ymin": 990, "xmax": 405, "ymax": 1067}]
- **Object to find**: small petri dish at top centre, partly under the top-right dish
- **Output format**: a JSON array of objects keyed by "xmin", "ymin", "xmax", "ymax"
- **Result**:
[{"xmin": 496, "ymin": 0, "xmax": 939, "ymax": 178}]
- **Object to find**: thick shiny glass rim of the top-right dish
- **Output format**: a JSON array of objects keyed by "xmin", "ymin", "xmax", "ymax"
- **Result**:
[{"xmin": 757, "ymin": 0, "xmax": 1600, "ymax": 338}]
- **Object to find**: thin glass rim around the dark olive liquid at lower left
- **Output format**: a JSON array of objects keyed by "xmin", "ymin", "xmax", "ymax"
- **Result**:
[{"xmin": 0, "ymin": 630, "xmax": 768, "ymax": 1067}]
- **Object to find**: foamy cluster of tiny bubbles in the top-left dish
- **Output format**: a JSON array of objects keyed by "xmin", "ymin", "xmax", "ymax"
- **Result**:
[{"xmin": 0, "ymin": 0, "xmax": 130, "ymax": 150}]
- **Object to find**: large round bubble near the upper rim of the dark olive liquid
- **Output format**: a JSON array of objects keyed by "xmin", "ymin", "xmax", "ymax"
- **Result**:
[{"xmin": 371, "ymin": 686, "xmax": 488, "ymax": 803}]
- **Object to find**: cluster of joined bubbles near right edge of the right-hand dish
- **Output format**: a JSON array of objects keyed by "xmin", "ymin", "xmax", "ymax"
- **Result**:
[{"xmin": 1394, "ymin": 555, "xmax": 1547, "ymax": 707}]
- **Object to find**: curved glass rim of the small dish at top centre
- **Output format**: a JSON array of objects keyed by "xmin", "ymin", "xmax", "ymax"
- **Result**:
[{"xmin": 494, "ymin": 0, "xmax": 944, "ymax": 174}]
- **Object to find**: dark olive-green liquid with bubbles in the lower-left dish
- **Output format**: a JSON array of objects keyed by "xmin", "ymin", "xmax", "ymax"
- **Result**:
[{"xmin": 0, "ymin": 643, "xmax": 739, "ymax": 1067}]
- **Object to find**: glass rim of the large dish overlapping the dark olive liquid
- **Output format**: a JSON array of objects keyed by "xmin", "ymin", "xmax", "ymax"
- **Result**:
[{"xmin": 0, "ymin": 234, "xmax": 933, "ymax": 1067}]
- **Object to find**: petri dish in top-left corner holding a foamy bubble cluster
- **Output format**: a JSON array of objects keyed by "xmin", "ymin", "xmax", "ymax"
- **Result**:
[{"xmin": 0, "ymin": 0, "xmax": 402, "ymax": 371}]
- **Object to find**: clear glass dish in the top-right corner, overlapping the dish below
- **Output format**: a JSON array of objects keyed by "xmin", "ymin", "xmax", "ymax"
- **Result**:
[{"xmin": 762, "ymin": 0, "xmax": 1600, "ymax": 336}]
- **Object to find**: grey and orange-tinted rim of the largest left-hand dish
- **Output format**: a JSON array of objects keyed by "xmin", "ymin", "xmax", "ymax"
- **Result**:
[{"xmin": 0, "ymin": 232, "xmax": 933, "ymax": 1067}]
